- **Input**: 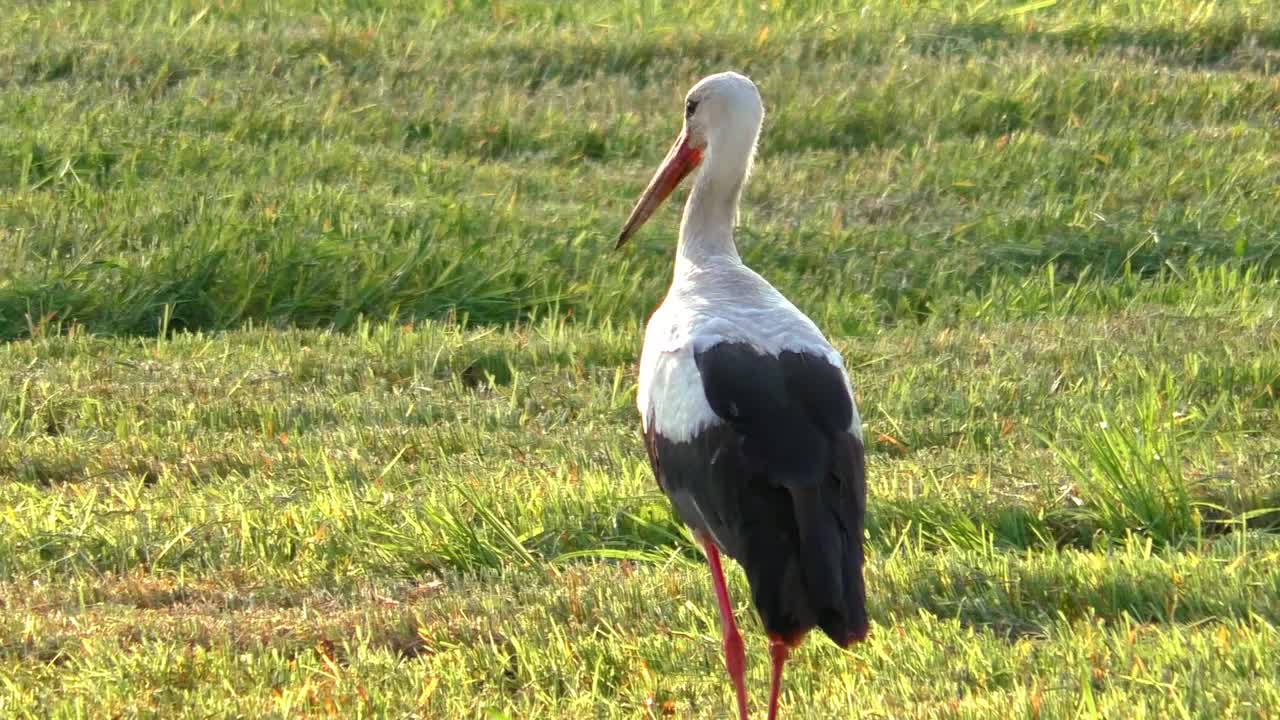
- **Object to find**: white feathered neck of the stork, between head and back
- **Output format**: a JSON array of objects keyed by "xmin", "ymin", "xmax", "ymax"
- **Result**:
[{"xmin": 676, "ymin": 147, "xmax": 750, "ymax": 269}]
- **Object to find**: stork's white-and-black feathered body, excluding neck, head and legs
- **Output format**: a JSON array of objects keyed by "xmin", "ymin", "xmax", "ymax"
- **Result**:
[{"xmin": 636, "ymin": 258, "xmax": 865, "ymax": 644}]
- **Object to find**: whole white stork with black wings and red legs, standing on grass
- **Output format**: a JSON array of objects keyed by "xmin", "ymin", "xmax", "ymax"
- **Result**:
[{"xmin": 618, "ymin": 72, "xmax": 868, "ymax": 720}]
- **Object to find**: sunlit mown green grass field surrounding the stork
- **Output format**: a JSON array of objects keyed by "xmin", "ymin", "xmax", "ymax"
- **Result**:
[{"xmin": 0, "ymin": 0, "xmax": 1280, "ymax": 719}]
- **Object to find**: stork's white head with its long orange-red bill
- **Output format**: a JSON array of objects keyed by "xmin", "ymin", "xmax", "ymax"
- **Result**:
[{"xmin": 617, "ymin": 72, "xmax": 764, "ymax": 247}]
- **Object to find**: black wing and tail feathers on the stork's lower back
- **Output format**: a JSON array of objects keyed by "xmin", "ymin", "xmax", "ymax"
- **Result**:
[{"xmin": 646, "ymin": 343, "xmax": 867, "ymax": 646}]
